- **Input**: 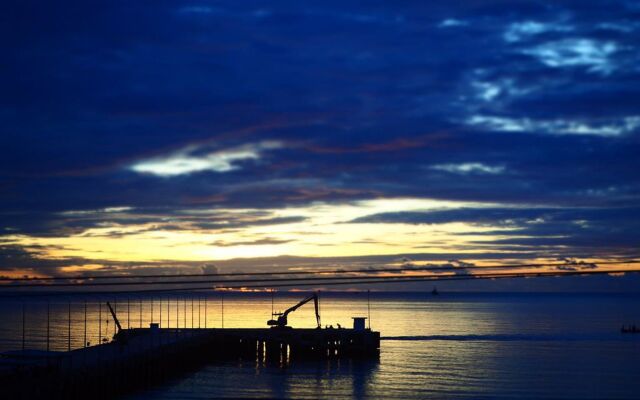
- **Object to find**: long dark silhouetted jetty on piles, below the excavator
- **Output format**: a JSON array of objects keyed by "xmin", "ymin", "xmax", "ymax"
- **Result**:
[{"xmin": 0, "ymin": 324, "xmax": 380, "ymax": 399}]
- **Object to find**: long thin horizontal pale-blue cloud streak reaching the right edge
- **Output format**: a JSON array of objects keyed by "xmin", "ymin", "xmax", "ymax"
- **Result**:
[{"xmin": 466, "ymin": 115, "xmax": 640, "ymax": 136}]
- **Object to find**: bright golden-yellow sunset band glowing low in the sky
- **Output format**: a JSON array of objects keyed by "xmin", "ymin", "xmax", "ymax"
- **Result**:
[{"xmin": 3, "ymin": 199, "xmax": 524, "ymax": 264}]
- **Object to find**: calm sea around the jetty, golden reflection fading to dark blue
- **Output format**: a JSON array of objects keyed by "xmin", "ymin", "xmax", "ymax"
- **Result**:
[{"xmin": 0, "ymin": 293, "xmax": 640, "ymax": 399}]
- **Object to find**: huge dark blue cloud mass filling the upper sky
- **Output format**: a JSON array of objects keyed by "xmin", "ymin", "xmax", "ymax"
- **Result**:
[{"xmin": 0, "ymin": 1, "xmax": 640, "ymax": 260}]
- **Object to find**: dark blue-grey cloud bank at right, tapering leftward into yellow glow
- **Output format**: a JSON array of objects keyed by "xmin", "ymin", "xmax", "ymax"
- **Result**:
[{"xmin": 349, "ymin": 207, "xmax": 640, "ymax": 251}]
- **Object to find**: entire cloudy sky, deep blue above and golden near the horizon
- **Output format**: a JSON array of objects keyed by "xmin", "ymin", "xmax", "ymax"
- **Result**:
[{"xmin": 0, "ymin": 0, "xmax": 640, "ymax": 288}]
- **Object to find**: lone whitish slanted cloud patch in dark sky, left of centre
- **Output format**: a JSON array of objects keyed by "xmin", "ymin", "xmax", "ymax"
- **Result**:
[{"xmin": 130, "ymin": 142, "xmax": 281, "ymax": 177}]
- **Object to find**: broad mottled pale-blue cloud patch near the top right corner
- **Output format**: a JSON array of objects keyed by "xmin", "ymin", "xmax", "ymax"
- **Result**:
[{"xmin": 523, "ymin": 39, "xmax": 618, "ymax": 74}]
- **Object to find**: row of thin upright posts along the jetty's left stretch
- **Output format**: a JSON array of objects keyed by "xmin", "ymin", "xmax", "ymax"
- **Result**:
[{"xmin": 0, "ymin": 293, "xmax": 224, "ymax": 352}]
